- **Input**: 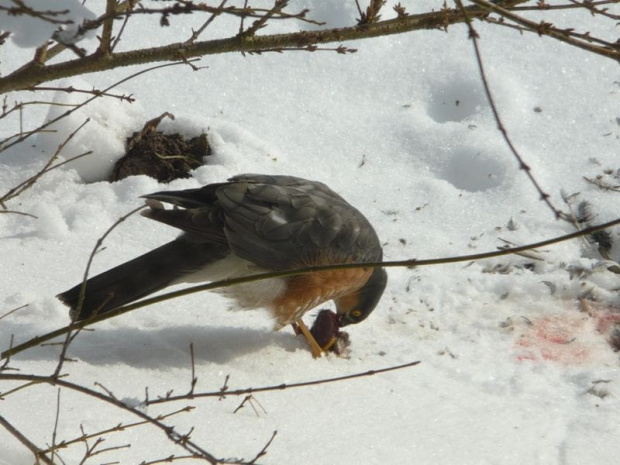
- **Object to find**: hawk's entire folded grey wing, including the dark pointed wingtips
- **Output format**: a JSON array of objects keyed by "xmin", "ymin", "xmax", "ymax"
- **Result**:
[{"xmin": 144, "ymin": 174, "xmax": 382, "ymax": 270}]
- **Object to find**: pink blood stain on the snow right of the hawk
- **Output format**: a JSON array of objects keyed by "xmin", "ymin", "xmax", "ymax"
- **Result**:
[{"xmin": 515, "ymin": 302, "xmax": 620, "ymax": 365}]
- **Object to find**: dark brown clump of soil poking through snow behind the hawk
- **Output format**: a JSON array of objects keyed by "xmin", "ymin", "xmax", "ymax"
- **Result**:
[{"xmin": 110, "ymin": 113, "xmax": 211, "ymax": 183}]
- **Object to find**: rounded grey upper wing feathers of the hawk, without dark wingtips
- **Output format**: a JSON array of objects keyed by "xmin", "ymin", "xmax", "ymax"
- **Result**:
[{"xmin": 216, "ymin": 175, "xmax": 381, "ymax": 269}]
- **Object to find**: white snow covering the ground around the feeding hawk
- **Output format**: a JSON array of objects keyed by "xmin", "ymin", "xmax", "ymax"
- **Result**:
[{"xmin": 0, "ymin": 0, "xmax": 620, "ymax": 465}]
